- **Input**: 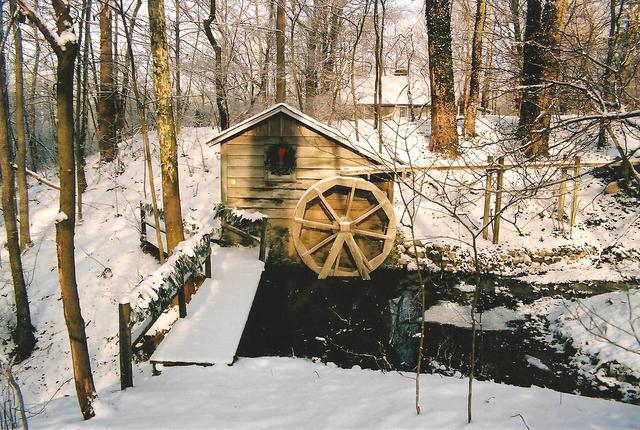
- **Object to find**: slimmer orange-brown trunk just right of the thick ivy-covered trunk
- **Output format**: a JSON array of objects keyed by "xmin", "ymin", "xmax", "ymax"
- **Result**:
[{"xmin": 462, "ymin": 0, "xmax": 487, "ymax": 137}]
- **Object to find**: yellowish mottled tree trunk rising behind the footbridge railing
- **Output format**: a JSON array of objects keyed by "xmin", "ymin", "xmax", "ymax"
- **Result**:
[{"xmin": 148, "ymin": 0, "xmax": 184, "ymax": 254}]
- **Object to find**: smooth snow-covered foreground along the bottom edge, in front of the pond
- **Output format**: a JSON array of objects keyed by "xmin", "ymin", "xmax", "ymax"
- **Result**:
[{"xmin": 30, "ymin": 358, "xmax": 640, "ymax": 430}]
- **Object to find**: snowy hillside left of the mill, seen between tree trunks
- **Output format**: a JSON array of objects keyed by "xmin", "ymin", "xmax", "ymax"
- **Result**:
[{"xmin": 0, "ymin": 128, "xmax": 220, "ymax": 408}]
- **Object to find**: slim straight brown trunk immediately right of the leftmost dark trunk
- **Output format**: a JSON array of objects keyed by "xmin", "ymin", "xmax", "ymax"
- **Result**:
[{"xmin": 10, "ymin": 1, "xmax": 31, "ymax": 249}]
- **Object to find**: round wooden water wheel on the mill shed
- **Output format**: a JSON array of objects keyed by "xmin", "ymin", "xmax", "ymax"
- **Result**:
[{"xmin": 292, "ymin": 176, "xmax": 396, "ymax": 279}]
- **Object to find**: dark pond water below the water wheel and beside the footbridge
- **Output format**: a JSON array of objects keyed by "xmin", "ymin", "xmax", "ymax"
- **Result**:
[{"xmin": 238, "ymin": 268, "xmax": 636, "ymax": 399}]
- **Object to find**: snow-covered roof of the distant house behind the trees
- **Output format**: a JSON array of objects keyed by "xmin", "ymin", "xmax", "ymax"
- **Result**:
[{"xmin": 348, "ymin": 75, "xmax": 431, "ymax": 105}]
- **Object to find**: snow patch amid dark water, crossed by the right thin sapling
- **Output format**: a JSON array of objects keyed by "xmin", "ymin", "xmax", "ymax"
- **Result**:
[{"xmin": 424, "ymin": 301, "xmax": 524, "ymax": 331}]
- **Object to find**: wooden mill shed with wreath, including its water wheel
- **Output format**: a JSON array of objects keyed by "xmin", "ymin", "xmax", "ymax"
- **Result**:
[{"xmin": 209, "ymin": 103, "xmax": 396, "ymax": 278}]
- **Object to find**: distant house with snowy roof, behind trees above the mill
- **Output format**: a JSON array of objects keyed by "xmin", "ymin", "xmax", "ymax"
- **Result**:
[{"xmin": 349, "ymin": 69, "xmax": 431, "ymax": 122}]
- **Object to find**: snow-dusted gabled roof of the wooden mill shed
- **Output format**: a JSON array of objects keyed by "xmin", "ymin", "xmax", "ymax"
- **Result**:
[{"xmin": 208, "ymin": 103, "xmax": 382, "ymax": 164}]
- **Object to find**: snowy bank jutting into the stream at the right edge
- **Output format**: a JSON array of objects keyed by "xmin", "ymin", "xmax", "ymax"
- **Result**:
[{"xmin": 547, "ymin": 289, "xmax": 640, "ymax": 377}]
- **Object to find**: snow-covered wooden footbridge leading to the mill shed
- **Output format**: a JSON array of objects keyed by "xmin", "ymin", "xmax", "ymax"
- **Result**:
[{"xmin": 151, "ymin": 245, "xmax": 264, "ymax": 364}]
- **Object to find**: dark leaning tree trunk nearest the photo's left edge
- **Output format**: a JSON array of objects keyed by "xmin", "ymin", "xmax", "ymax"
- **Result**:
[{"xmin": 0, "ymin": 10, "xmax": 36, "ymax": 361}]
